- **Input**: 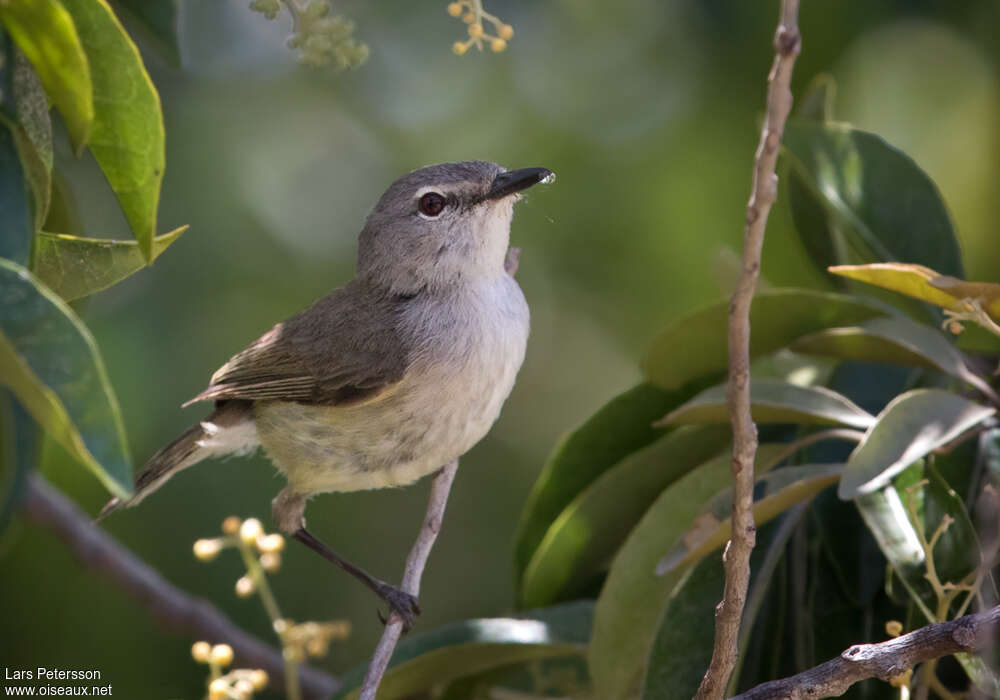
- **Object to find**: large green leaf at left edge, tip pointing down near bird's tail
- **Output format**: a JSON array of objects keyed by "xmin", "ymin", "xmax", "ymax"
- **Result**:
[{"xmin": 0, "ymin": 259, "xmax": 132, "ymax": 497}]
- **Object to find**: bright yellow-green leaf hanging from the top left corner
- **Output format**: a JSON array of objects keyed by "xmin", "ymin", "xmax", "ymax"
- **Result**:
[{"xmin": 0, "ymin": 0, "xmax": 94, "ymax": 150}]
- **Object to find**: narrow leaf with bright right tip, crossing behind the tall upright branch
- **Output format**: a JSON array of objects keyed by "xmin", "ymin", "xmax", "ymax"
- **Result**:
[{"xmin": 655, "ymin": 377, "xmax": 875, "ymax": 428}]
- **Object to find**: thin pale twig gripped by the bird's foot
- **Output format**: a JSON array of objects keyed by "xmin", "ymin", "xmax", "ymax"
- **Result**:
[{"xmin": 360, "ymin": 459, "xmax": 458, "ymax": 700}]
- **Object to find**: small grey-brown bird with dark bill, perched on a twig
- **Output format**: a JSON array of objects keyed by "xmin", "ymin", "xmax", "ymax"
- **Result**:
[{"xmin": 99, "ymin": 161, "xmax": 554, "ymax": 622}]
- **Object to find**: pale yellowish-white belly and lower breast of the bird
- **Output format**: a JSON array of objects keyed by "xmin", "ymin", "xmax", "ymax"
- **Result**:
[{"xmin": 255, "ymin": 278, "xmax": 528, "ymax": 495}]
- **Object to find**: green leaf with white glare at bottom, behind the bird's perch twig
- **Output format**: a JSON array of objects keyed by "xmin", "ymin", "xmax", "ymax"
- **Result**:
[{"xmin": 336, "ymin": 601, "xmax": 593, "ymax": 700}]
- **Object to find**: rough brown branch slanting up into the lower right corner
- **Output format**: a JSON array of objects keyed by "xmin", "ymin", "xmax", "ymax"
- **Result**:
[{"xmin": 733, "ymin": 605, "xmax": 1000, "ymax": 700}]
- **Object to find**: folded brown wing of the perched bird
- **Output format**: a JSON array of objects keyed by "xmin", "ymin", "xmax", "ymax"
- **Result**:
[{"xmin": 185, "ymin": 283, "xmax": 409, "ymax": 406}]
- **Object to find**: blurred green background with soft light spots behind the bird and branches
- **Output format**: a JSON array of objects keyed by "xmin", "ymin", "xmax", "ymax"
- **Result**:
[{"xmin": 0, "ymin": 0, "xmax": 1000, "ymax": 698}]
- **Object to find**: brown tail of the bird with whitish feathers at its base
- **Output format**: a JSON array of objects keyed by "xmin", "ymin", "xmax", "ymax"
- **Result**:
[{"xmin": 97, "ymin": 400, "xmax": 257, "ymax": 520}]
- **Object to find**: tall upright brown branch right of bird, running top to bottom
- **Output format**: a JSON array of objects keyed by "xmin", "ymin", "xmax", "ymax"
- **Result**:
[{"xmin": 695, "ymin": 0, "xmax": 801, "ymax": 700}]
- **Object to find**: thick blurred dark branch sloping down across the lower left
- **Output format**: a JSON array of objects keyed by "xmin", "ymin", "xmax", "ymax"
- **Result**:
[{"xmin": 21, "ymin": 474, "xmax": 340, "ymax": 700}]
